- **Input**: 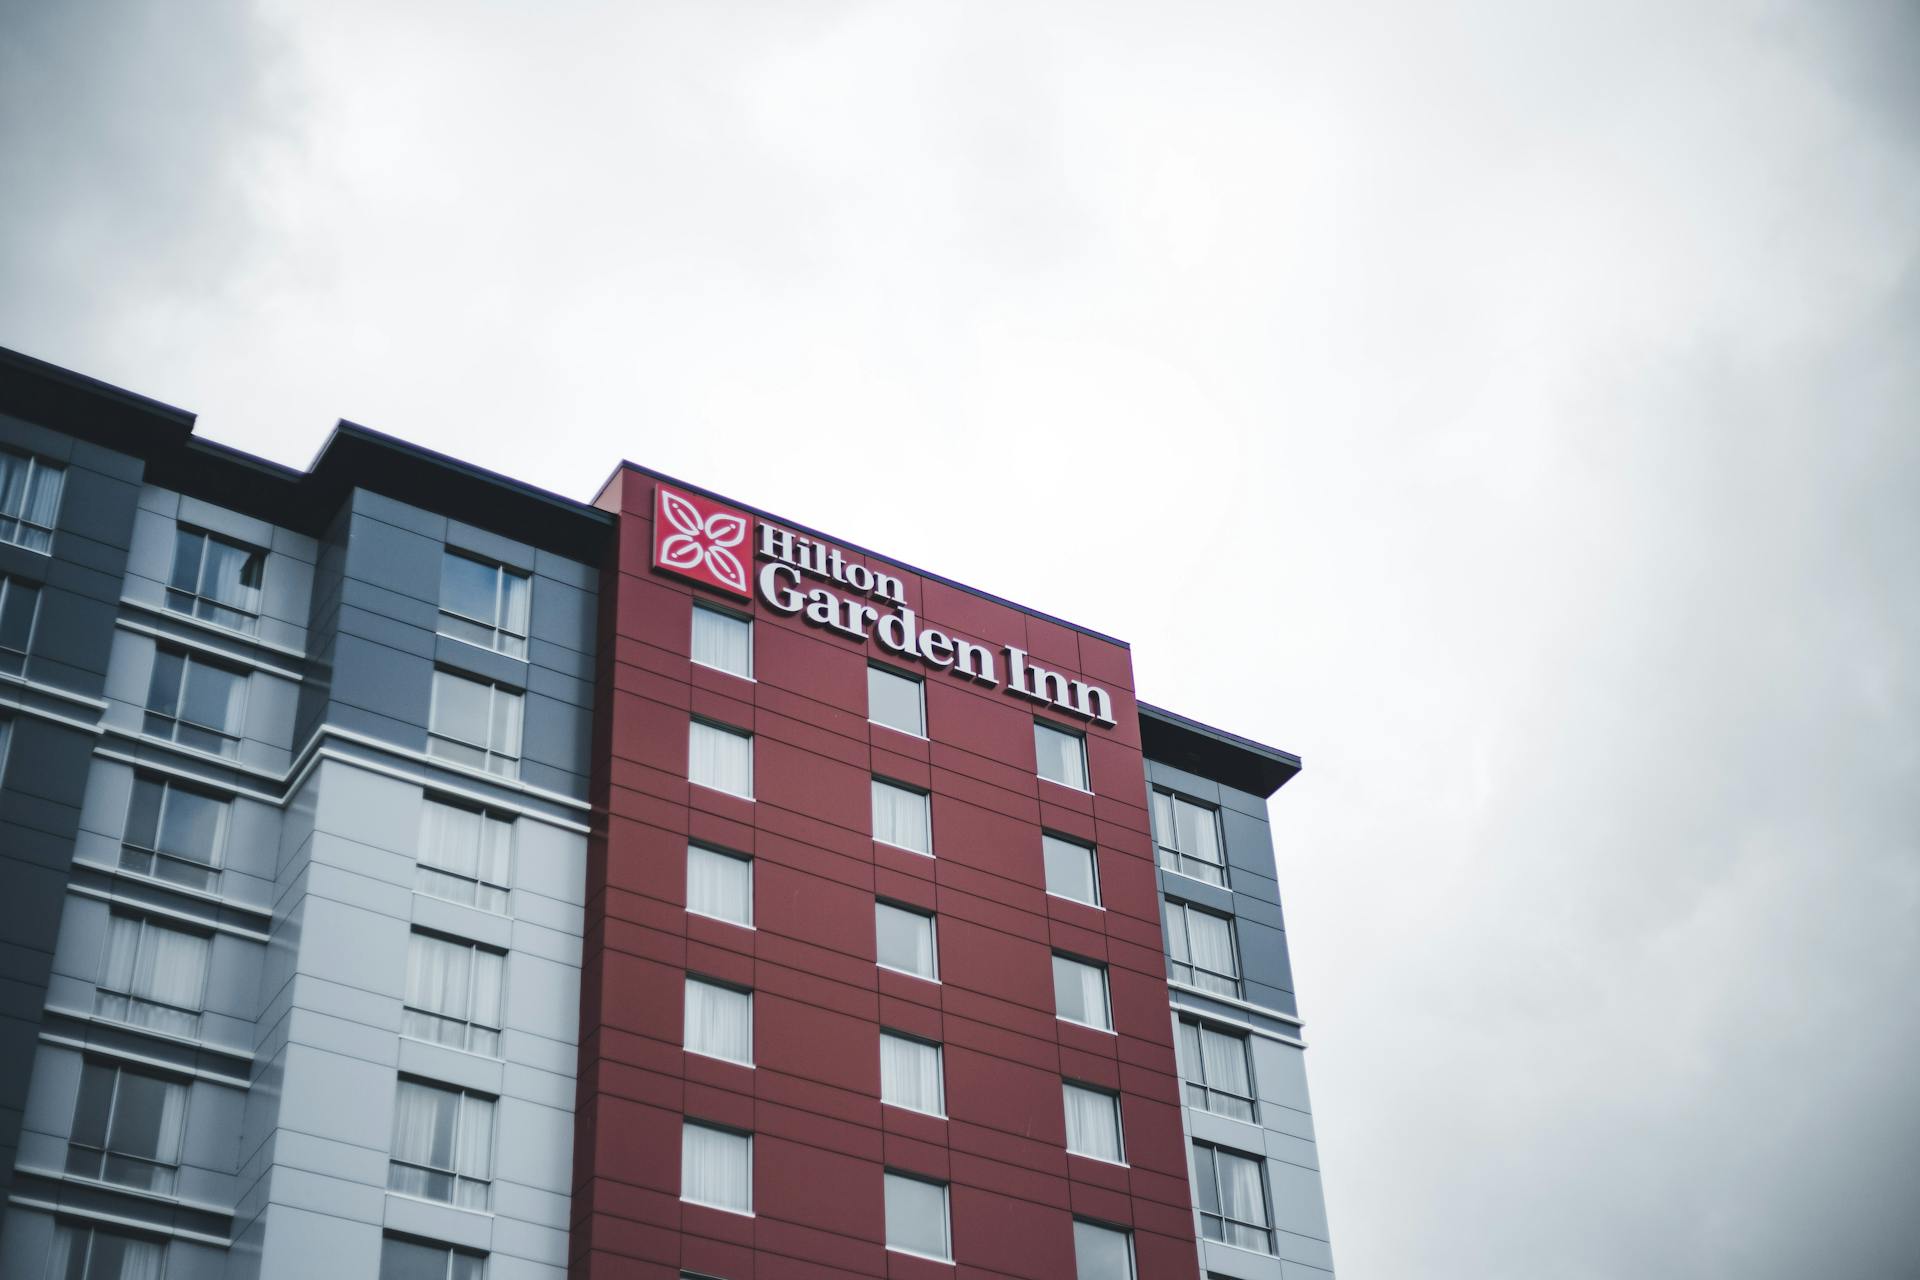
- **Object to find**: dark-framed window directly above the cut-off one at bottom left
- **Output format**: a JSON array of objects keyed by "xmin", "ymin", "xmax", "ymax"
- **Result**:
[{"xmin": 67, "ymin": 1059, "xmax": 186, "ymax": 1196}]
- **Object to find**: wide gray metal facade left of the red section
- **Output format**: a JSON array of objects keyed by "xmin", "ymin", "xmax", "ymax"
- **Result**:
[{"xmin": 0, "ymin": 383, "xmax": 597, "ymax": 1280}]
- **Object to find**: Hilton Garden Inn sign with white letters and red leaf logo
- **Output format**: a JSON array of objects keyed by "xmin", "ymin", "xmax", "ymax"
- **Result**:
[{"xmin": 653, "ymin": 484, "xmax": 1114, "ymax": 725}]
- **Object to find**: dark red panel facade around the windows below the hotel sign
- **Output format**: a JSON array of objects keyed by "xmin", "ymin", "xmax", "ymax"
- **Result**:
[{"xmin": 572, "ymin": 466, "xmax": 1196, "ymax": 1280}]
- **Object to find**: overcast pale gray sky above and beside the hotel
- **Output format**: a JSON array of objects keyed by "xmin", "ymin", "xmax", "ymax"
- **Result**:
[{"xmin": 0, "ymin": 0, "xmax": 1920, "ymax": 1280}]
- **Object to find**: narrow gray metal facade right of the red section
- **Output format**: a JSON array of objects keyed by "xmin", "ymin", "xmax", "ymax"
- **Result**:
[{"xmin": 1146, "ymin": 756, "xmax": 1332, "ymax": 1280}]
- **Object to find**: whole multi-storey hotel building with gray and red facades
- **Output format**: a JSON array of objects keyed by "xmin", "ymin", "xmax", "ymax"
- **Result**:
[{"xmin": 0, "ymin": 351, "xmax": 1332, "ymax": 1280}]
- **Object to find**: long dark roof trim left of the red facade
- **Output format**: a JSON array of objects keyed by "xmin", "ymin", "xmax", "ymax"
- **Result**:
[{"xmin": 0, "ymin": 347, "xmax": 614, "ymax": 564}]
